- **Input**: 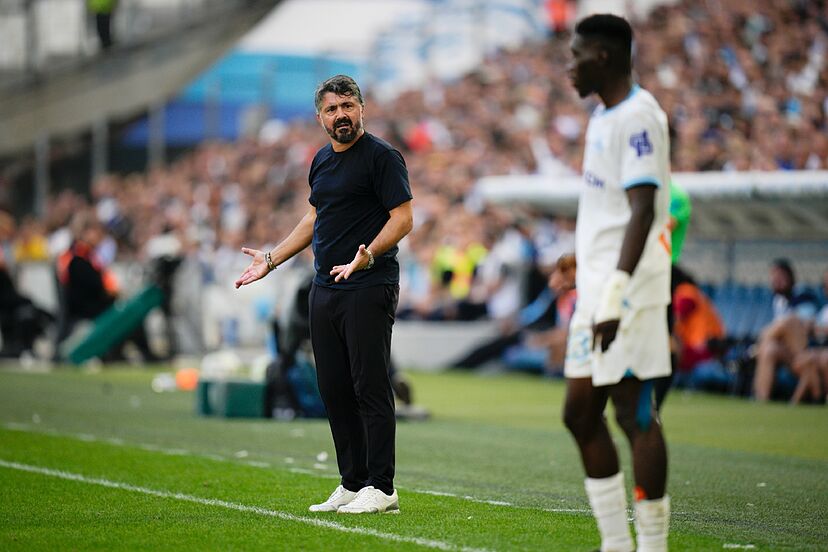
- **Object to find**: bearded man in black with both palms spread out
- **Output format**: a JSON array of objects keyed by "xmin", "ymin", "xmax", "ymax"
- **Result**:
[{"xmin": 236, "ymin": 75, "xmax": 413, "ymax": 513}]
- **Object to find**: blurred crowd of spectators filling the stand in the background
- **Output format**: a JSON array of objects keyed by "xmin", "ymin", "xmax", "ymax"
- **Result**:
[{"xmin": 0, "ymin": 0, "xmax": 828, "ymax": 396}]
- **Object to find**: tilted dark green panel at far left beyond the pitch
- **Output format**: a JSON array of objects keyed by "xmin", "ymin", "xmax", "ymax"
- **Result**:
[{"xmin": 66, "ymin": 286, "xmax": 164, "ymax": 364}]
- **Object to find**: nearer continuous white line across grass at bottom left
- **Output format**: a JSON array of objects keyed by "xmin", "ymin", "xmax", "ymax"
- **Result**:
[{"xmin": 0, "ymin": 460, "xmax": 485, "ymax": 552}]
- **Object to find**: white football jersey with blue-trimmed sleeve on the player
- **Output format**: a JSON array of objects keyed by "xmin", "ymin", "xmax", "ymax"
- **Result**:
[{"xmin": 575, "ymin": 85, "xmax": 670, "ymax": 313}]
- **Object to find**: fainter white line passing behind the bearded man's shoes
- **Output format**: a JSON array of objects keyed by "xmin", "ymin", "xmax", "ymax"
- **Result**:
[{"xmin": 4, "ymin": 422, "xmax": 592, "ymax": 515}]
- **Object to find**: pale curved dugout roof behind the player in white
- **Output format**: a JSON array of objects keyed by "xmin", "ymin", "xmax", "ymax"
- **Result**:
[{"xmin": 475, "ymin": 171, "xmax": 828, "ymax": 241}]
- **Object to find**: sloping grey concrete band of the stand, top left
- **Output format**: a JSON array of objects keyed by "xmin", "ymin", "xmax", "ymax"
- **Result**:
[{"xmin": 0, "ymin": 0, "xmax": 282, "ymax": 157}]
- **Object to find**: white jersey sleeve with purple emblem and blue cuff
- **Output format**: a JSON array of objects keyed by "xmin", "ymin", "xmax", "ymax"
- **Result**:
[{"xmin": 619, "ymin": 111, "xmax": 670, "ymax": 189}]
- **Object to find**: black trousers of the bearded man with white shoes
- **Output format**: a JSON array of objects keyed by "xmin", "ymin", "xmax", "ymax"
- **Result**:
[{"xmin": 310, "ymin": 284, "xmax": 399, "ymax": 494}]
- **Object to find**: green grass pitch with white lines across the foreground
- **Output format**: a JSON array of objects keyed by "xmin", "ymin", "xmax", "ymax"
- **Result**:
[{"xmin": 0, "ymin": 367, "xmax": 828, "ymax": 551}]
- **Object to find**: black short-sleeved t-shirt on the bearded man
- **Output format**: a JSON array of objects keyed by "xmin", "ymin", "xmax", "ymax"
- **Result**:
[{"xmin": 308, "ymin": 132, "xmax": 411, "ymax": 289}]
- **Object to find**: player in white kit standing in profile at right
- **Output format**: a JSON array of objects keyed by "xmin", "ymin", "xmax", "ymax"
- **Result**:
[{"xmin": 564, "ymin": 14, "xmax": 670, "ymax": 551}]
